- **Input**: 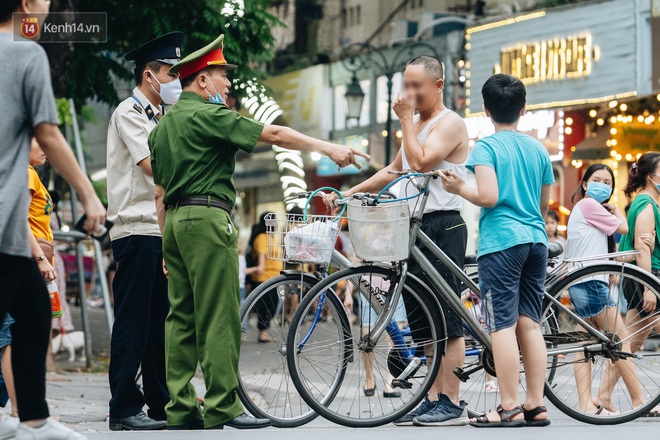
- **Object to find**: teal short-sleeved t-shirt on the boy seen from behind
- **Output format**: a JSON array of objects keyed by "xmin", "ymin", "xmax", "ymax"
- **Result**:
[{"xmin": 466, "ymin": 131, "xmax": 555, "ymax": 256}]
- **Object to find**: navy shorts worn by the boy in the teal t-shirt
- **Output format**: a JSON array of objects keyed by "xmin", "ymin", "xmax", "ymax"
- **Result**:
[{"xmin": 477, "ymin": 243, "xmax": 548, "ymax": 333}]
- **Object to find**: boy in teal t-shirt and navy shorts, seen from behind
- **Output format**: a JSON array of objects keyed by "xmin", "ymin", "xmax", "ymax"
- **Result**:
[{"xmin": 441, "ymin": 74, "xmax": 554, "ymax": 427}]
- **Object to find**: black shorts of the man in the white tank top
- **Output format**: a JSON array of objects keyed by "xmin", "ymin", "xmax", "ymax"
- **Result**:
[{"xmin": 403, "ymin": 211, "xmax": 467, "ymax": 341}]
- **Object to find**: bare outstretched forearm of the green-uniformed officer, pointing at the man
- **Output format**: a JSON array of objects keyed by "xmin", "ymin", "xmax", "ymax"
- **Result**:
[{"xmin": 259, "ymin": 125, "xmax": 370, "ymax": 171}]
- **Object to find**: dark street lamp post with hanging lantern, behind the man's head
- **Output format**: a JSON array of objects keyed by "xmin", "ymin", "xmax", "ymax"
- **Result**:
[{"xmin": 342, "ymin": 42, "xmax": 440, "ymax": 165}]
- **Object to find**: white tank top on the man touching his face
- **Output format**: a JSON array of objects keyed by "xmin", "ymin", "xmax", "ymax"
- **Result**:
[{"xmin": 399, "ymin": 108, "xmax": 467, "ymax": 214}]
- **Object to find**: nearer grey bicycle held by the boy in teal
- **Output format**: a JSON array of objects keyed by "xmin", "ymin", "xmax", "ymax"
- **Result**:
[{"xmin": 286, "ymin": 171, "xmax": 660, "ymax": 427}]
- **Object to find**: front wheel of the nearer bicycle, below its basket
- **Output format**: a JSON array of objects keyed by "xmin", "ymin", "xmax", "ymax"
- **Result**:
[{"xmin": 287, "ymin": 266, "xmax": 446, "ymax": 427}]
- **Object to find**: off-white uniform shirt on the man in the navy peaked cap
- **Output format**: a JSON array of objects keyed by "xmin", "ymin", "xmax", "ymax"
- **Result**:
[{"xmin": 107, "ymin": 87, "xmax": 160, "ymax": 240}]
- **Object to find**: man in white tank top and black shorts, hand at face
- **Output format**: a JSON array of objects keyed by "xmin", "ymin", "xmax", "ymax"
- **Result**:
[{"xmin": 328, "ymin": 56, "xmax": 469, "ymax": 426}]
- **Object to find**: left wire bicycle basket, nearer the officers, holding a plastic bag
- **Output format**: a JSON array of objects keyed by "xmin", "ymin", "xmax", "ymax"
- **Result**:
[{"xmin": 266, "ymin": 213, "xmax": 339, "ymax": 265}]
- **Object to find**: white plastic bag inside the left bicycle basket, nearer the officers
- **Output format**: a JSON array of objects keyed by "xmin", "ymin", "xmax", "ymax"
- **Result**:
[{"xmin": 284, "ymin": 220, "xmax": 337, "ymax": 264}]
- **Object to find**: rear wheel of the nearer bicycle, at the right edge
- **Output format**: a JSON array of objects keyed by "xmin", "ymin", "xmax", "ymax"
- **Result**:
[{"xmin": 543, "ymin": 262, "xmax": 660, "ymax": 425}]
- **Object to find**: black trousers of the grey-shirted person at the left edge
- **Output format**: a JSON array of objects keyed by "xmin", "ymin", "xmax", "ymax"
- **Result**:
[{"xmin": 0, "ymin": 253, "xmax": 51, "ymax": 421}]
